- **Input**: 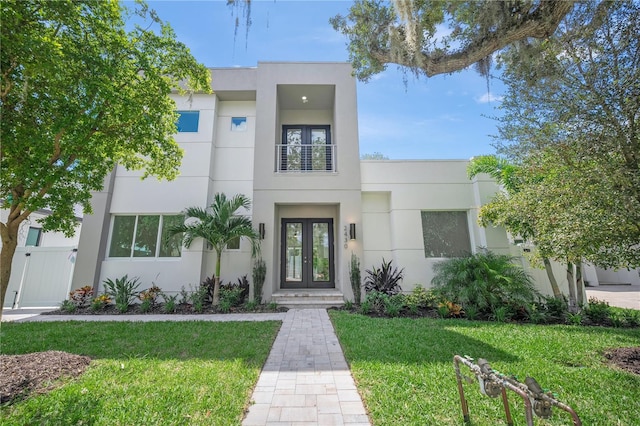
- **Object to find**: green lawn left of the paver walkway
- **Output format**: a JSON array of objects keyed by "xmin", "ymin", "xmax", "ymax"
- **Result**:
[{"xmin": 0, "ymin": 321, "xmax": 280, "ymax": 426}]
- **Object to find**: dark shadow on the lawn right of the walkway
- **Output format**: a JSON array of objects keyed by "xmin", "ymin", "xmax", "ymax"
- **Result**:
[{"xmin": 331, "ymin": 313, "xmax": 519, "ymax": 364}]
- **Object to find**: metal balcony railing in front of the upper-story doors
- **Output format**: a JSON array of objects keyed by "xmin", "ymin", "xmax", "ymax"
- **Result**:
[{"xmin": 275, "ymin": 144, "xmax": 337, "ymax": 173}]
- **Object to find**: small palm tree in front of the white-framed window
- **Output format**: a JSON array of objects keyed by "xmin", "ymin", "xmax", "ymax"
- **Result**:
[{"xmin": 169, "ymin": 193, "xmax": 260, "ymax": 306}]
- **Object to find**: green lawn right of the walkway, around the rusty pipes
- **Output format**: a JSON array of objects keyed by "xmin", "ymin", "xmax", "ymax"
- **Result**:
[{"xmin": 330, "ymin": 311, "xmax": 640, "ymax": 426}]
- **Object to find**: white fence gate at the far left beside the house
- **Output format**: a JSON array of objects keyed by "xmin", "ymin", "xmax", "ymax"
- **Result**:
[{"xmin": 4, "ymin": 247, "xmax": 77, "ymax": 308}]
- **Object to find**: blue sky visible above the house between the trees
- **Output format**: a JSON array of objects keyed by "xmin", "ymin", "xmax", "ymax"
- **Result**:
[{"xmin": 142, "ymin": 0, "xmax": 502, "ymax": 159}]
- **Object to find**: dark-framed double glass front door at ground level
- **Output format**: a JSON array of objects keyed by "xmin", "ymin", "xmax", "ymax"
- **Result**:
[{"xmin": 281, "ymin": 219, "xmax": 335, "ymax": 288}]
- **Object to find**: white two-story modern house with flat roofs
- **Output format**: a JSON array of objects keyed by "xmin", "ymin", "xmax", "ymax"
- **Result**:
[{"xmin": 73, "ymin": 62, "xmax": 640, "ymax": 301}]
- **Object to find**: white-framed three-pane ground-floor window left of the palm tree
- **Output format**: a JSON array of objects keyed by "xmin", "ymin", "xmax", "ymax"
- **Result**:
[{"xmin": 109, "ymin": 215, "xmax": 184, "ymax": 258}]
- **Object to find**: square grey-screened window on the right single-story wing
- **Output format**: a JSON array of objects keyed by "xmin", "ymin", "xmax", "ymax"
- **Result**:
[{"xmin": 421, "ymin": 211, "xmax": 471, "ymax": 257}]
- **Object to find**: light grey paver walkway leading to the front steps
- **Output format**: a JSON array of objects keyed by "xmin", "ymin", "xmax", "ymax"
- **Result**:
[{"xmin": 242, "ymin": 309, "xmax": 370, "ymax": 426}]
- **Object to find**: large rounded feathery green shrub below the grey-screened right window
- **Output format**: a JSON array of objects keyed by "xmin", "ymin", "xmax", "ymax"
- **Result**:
[{"xmin": 432, "ymin": 250, "xmax": 541, "ymax": 316}]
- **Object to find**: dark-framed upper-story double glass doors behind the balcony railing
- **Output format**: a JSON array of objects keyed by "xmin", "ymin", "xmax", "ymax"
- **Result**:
[{"xmin": 278, "ymin": 125, "xmax": 335, "ymax": 172}]
